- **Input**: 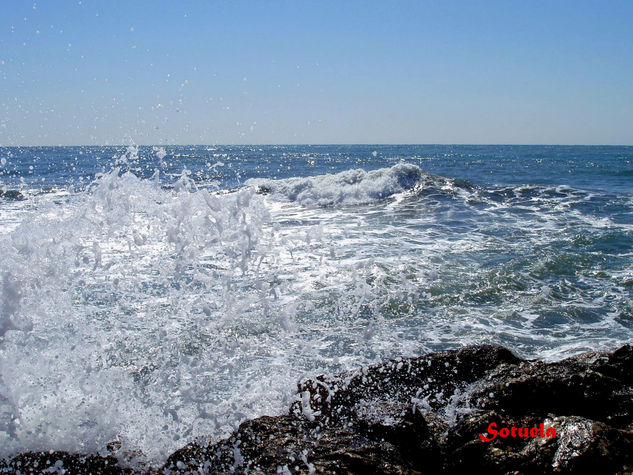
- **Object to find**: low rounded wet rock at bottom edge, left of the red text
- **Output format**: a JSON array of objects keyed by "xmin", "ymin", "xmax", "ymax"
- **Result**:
[{"xmin": 161, "ymin": 416, "xmax": 414, "ymax": 474}]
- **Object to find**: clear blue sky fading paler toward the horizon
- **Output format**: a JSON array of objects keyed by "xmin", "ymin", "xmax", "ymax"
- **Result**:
[{"xmin": 0, "ymin": 0, "xmax": 633, "ymax": 146}]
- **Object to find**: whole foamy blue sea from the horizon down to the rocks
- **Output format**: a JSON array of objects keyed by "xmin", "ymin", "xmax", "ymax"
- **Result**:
[{"xmin": 0, "ymin": 145, "xmax": 633, "ymax": 463}]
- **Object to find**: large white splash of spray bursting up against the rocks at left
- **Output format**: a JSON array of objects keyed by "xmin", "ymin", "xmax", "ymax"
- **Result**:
[{"xmin": 0, "ymin": 168, "xmax": 287, "ymax": 457}]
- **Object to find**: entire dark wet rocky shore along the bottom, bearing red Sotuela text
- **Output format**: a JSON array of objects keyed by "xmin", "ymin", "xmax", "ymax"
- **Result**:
[{"xmin": 0, "ymin": 345, "xmax": 633, "ymax": 474}]
